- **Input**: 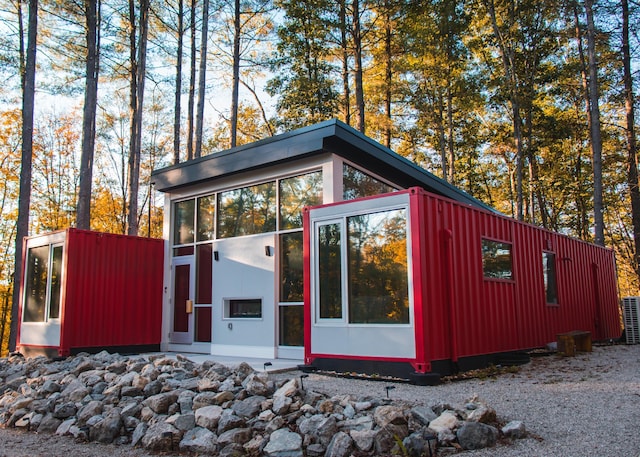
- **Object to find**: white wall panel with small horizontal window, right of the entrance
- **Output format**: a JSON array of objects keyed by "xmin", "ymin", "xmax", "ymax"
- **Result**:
[{"xmin": 211, "ymin": 233, "xmax": 276, "ymax": 358}]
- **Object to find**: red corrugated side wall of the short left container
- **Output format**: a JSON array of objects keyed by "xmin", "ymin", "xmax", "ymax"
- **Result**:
[{"xmin": 60, "ymin": 229, "xmax": 164, "ymax": 353}]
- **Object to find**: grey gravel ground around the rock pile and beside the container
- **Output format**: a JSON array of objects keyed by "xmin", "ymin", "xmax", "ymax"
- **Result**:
[{"xmin": 0, "ymin": 345, "xmax": 640, "ymax": 457}]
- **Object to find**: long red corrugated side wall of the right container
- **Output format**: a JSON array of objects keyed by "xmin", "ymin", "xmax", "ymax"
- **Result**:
[{"xmin": 414, "ymin": 186, "xmax": 620, "ymax": 361}]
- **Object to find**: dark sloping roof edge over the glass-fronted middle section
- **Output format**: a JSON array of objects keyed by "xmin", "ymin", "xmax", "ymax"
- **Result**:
[{"xmin": 151, "ymin": 119, "xmax": 495, "ymax": 211}]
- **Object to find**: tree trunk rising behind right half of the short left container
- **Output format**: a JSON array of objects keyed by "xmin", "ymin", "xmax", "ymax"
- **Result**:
[{"xmin": 127, "ymin": 0, "xmax": 149, "ymax": 235}]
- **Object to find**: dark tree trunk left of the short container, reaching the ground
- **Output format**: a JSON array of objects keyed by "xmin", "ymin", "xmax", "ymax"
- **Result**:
[{"xmin": 9, "ymin": 0, "xmax": 38, "ymax": 351}]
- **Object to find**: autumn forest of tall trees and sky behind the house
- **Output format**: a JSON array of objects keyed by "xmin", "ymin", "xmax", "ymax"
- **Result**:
[{"xmin": 0, "ymin": 0, "xmax": 640, "ymax": 355}]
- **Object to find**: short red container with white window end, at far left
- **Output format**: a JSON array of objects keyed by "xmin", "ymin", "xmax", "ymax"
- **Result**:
[{"xmin": 18, "ymin": 228, "xmax": 164, "ymax": 356}]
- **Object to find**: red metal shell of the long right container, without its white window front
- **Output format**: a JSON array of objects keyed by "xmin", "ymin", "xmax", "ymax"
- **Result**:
[{"xmin": 305, "ymin": 188, "xmax": 621, "ymax": 380}]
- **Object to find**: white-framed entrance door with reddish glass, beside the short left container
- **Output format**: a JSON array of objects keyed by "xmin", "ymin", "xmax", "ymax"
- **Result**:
[{"xmin": 169, "ymin": 256, "xmax": 195, "ymax": 344}]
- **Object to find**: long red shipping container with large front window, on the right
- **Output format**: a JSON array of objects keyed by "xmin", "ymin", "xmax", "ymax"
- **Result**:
[{"xmin": 304, "ymin": 188, "xmax": 622, "ymax": 378}]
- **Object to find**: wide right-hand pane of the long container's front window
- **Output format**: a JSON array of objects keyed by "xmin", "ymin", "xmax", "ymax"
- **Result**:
[{"xmin": 347, "ymin": 209, "xmax": 409, "ymax": 324}]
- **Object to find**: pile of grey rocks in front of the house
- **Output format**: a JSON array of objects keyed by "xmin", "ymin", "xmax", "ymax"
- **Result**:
[{"xmin": 0, "ymin": 352, "xmax": 527, "ymax": 457}]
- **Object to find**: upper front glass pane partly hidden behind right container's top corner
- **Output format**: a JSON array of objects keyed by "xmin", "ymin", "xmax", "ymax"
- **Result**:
[{"xmin": 280, "ymin": 171, "xmax": 322, "ymax": 230}]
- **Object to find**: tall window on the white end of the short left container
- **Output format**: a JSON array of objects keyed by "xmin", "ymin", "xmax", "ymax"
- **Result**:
[{"xmin": 23, "ymin": 245, "xmax": 63, "ymax": 322}]
